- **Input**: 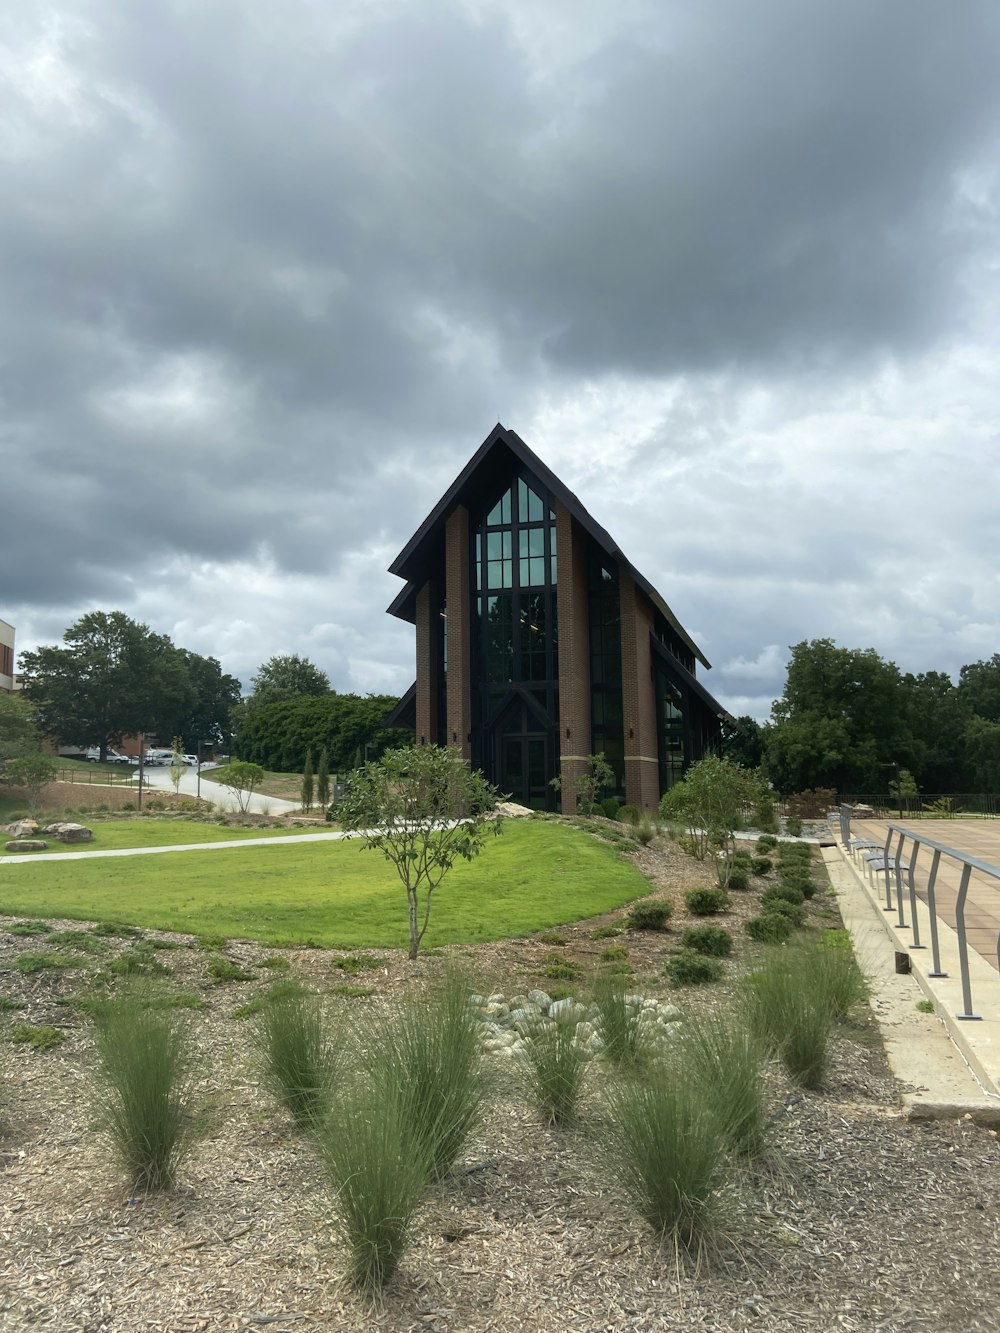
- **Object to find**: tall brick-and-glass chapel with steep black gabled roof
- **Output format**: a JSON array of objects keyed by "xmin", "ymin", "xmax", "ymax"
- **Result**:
[{"xmin": 388, "ymin": 424, "xmax": 727, "ymax": 813}]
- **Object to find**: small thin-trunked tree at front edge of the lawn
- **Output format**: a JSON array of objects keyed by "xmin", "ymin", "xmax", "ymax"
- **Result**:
[{"xmin": 337, "ymin": 745, "xmax": 500, "ymax": 958}]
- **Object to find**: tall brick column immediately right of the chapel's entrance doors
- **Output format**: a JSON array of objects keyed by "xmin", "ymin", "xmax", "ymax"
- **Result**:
[{"xmin": 556, "ymin": 503, "xmax": 591, "ymax": 814}]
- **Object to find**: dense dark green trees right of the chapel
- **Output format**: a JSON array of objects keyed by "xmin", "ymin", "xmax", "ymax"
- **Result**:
[{"xmin": 724, "ymin": 639, "xmax": 1000, "ymax": 794}]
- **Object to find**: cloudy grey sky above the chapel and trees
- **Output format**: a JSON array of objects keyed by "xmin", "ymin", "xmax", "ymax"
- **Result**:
[{"xmin": 0, "ymin": 0, "xmax": 1000, "ymax": 717}]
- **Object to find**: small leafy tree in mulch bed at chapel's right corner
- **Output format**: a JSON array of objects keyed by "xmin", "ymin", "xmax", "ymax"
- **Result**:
[{"xmin": 660, "ymin": 754, "xmax": 765, "ymax": 884}]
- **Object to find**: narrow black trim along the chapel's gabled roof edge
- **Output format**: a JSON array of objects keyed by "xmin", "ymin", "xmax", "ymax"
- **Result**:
[{"xmin": 388, "ymin": 421, "xmax": 712, "ymax": 667}]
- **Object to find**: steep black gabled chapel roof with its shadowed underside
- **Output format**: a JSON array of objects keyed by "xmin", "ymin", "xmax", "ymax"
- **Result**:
[{"xmin": 388, "ymin": 421, "xmax": 711, "ymax": 667}]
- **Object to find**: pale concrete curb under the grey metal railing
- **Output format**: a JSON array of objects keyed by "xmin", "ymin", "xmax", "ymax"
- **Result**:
[{"xmin": 823, "ymin": 845, "xmax": 1000, "ymax": 1128}]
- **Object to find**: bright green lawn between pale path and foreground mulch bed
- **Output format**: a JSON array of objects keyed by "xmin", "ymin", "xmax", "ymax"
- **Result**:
[{"xmin": 0, "ymin": 820, "xmax": 649, "ymax": 949}]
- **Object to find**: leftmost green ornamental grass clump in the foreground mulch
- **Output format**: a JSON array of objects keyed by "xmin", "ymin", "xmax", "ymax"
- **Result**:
[{"xmin": 95, "ymin": 992, "xmax": 197, "ymax": 1190}]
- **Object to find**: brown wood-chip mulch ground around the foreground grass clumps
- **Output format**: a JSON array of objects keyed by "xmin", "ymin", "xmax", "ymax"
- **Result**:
[{"xmin": 0, "ymin": 840, "xmax": 1000, "ymax": 1333}]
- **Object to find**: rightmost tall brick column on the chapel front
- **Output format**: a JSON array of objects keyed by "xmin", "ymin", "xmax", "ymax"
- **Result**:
[{"xmin": 619, "ymin": 569, "xmax": 660, "ymax": 810}]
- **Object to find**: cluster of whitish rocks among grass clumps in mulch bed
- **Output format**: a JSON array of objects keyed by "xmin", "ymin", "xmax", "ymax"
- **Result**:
[{"xmin": 471, "ymin": 989, "xmax": 681, "ymax": 1060}]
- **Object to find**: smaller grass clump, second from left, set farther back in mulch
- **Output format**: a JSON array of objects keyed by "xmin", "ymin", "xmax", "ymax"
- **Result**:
[{"xmin": 256, "ymin": 992, "xmax": 343, "ymax": 1132}]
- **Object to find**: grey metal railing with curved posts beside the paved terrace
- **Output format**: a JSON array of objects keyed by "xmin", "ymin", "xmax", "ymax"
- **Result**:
[{"xmin": 840, "ymin": 804, "xmax": 1000, "ymax": 1020}]
